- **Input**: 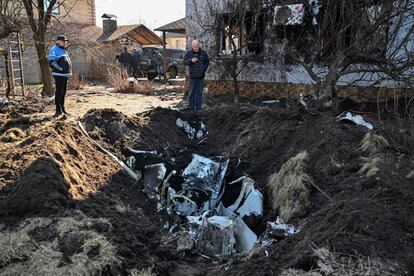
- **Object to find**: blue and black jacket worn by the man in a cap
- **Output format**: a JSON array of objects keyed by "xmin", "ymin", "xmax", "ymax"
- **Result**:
[{"xmin": 49, "ymin": 45, "xmax": 72, "ymax": 78}]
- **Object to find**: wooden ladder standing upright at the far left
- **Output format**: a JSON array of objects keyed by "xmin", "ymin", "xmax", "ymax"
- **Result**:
[{"xmin": 6, "ymin": 33, "xmax": 25, "ymax": 97}]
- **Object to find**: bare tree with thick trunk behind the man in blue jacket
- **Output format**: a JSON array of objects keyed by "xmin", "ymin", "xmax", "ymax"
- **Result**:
[{"xmin": 20, "ymin": 0, "xmax": 77, "ymax": 96}]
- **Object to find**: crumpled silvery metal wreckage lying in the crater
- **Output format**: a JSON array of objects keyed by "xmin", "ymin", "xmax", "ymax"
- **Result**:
[{"xmin": 127, "ymin": 118, "xmax": 296, "ymax": 258}]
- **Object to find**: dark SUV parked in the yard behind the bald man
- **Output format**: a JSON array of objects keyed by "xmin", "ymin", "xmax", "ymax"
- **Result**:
[{"xmin": 139, "ymin": 47, "xmax": 185, "ymax": 80}]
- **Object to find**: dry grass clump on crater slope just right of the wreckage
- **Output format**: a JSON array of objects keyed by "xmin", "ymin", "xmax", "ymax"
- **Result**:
[{"xmin": 267, "ymin": 151, "xmax": 312, "ymax": 222}]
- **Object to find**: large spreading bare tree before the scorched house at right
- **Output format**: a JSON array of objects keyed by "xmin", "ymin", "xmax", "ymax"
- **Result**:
[{"xmin": 284, "ymin": 0, "xmax": 414, "ymax": 105}]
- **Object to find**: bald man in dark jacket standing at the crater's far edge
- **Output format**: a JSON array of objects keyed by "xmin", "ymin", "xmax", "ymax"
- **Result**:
[{"xmin": 184, "ymin": 40, "xmax": 210, "ymax": 110}]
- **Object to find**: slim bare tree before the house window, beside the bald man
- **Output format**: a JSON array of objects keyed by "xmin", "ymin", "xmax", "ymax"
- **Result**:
[{"xmin": 193, "ymin": 0, "xmax": 261, "ymax": 104}]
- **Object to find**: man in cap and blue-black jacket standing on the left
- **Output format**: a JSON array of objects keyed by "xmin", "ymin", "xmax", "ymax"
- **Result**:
[{"xmin": 49, "ymin": 35, "xmax": 72, "ymax": 116}]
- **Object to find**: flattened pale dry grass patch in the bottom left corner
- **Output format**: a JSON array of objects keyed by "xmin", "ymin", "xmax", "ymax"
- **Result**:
[{"xmin": 0, "ymin": 214, "xmax": 120, "ymax": 275}]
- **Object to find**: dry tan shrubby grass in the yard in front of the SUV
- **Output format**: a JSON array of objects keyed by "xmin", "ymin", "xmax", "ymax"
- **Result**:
[{"xmin": 106, "ymin": 66, "xmax": 152, "ymax": 95}]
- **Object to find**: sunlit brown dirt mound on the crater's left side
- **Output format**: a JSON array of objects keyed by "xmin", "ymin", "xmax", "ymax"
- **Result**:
[{"xmin": 0, "ymin": 119, "xmax": 118, "ymax": 221}]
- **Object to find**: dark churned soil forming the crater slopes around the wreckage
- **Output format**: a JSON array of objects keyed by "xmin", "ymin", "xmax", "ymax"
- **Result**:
[{"xmin": 0, "ymin": 102, "xmax": 414, "ymax": 275}]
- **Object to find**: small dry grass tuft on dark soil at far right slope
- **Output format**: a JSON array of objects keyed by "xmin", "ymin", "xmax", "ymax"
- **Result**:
[{"xmin": 359, "ymin": 133, "xmax": 389, "ymax": 178}]
